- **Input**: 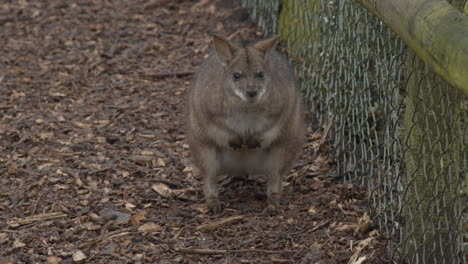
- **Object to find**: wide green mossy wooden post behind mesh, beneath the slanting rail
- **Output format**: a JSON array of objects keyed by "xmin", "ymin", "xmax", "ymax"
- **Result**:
[{"xmin": 402, "ymin": 52, "xmax": 467, "ymax": 264}]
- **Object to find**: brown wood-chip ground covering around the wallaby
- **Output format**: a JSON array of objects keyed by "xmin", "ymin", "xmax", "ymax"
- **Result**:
[{"xmin": 0, "ymin": 0, "xmax": 387, "ymax": 264}]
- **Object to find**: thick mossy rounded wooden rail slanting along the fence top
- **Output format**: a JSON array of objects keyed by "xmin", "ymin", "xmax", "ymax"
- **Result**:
[{"xmin": 358, "ymin": 0, "xmax": 468, "ymax": 93}]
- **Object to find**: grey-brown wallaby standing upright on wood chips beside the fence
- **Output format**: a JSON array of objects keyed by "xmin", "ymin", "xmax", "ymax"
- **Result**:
[{"xmin": 187, "ymin": 35, "xmax": 304, "ymax": 212}]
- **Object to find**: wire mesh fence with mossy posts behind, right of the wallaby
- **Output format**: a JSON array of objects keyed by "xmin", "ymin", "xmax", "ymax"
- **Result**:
[{"xmin": 243, "ymin": 0, "xmax": 468, "ymax": 264}]
